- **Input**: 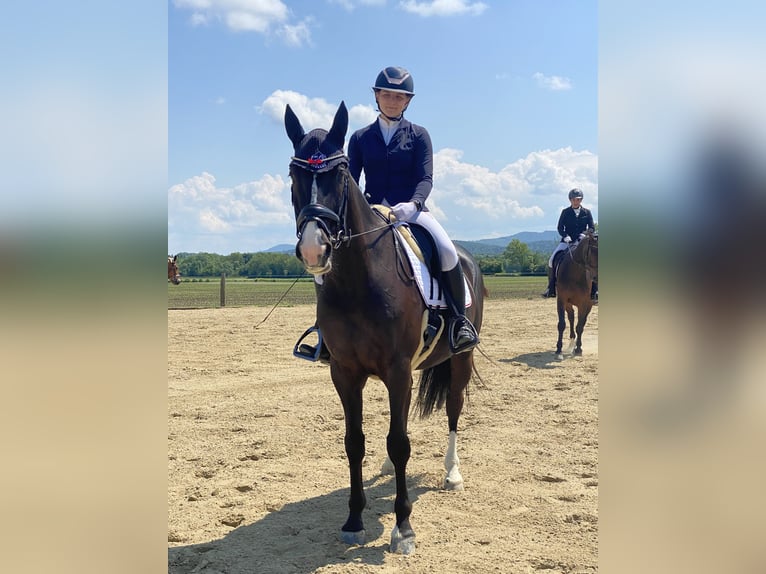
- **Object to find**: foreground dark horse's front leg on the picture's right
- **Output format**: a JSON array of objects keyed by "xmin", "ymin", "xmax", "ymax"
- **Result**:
[{"xmin": 386, "ymin": 363, "xmax": 415, "ymax": 554}]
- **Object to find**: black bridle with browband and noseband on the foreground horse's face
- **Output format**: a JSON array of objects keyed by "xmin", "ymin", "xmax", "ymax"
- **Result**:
[{"xmin": 290, "ymin": 151, "xmax": 349, "ymax": 249}]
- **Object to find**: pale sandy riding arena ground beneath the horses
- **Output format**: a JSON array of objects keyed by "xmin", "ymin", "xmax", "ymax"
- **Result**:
[{"xmin": 168, "ymin": 299, "xmax": 599, "ymax": 574}]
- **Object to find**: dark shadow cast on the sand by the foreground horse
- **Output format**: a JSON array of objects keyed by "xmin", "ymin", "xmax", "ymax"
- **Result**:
[{"xmin": 168, "ymin": 476, "xmax": 435, "ymax": 574}]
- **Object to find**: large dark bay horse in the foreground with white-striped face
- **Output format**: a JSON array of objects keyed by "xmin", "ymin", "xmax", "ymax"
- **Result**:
[{"xmin": 284, "ymin": 102, "xmax": 487, "ymax": 554}]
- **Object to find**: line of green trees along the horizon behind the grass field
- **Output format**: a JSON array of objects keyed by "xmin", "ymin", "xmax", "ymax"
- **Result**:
[{"xmin": 170, "ymin": 239, "xmax": 553, "ymax": 278}]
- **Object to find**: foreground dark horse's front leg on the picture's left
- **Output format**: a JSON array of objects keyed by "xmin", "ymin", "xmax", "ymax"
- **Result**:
[{"xmin": 332, "ymin": 368, "xmax": 367, "ymax": 544}]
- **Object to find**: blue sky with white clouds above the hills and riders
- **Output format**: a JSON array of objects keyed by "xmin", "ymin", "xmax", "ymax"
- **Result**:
[{"xmin": 168, "ymin": 0, "xmax": 598, "ymax": 254}]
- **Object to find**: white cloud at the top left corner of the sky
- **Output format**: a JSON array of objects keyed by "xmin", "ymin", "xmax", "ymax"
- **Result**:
[{"xmin": 173, "ymin": 0, "xmax": 311, "ymax": 46}]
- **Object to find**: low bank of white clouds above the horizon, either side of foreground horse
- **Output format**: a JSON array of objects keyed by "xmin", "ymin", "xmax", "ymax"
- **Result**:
[{"xmin": 168, "ymin": 146, "xmax": 598, "ymax": 254}]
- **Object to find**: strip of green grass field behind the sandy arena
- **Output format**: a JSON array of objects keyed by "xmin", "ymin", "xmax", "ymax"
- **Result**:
[{"xmin": 168, "ymin": 276, "xmax": 547, "ymax": 309}]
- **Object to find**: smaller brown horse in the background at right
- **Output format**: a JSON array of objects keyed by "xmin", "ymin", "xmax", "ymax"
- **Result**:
[{"xmin": 555, "ymin": 230, "xmax": 598, "ymax": 358}]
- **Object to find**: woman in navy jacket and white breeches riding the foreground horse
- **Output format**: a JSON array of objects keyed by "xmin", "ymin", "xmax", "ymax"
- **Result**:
[{"xmin": 348, "ymin": 66, "xmax": 479, "ymax": 353}]
